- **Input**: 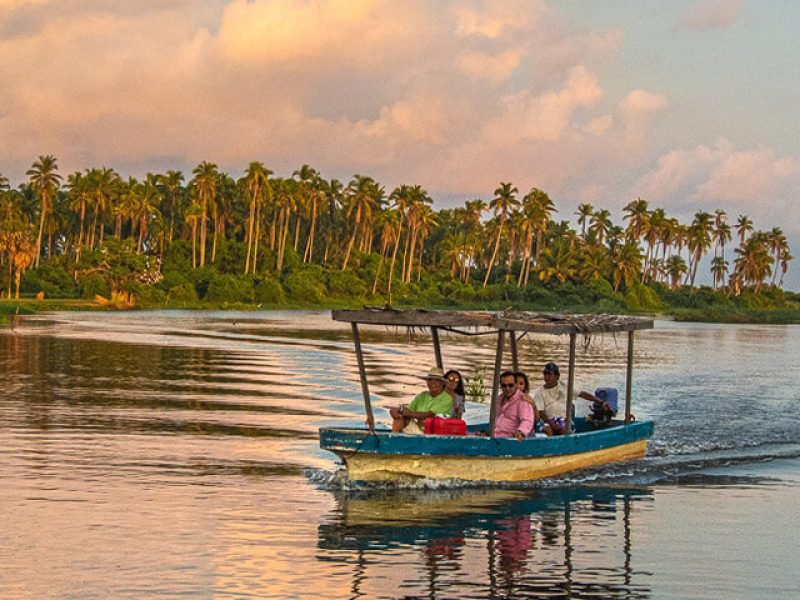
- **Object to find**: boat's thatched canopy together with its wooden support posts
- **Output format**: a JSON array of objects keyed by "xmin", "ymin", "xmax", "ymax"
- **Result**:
[{"xmin": 331, "ymin": 307, "xmax": 654, "ymax": 431}]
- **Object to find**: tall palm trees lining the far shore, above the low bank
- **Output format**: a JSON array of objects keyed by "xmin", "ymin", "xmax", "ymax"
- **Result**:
[{"xmin": 0, "ymin": 155, "xmax": 794, "ymax": 310}]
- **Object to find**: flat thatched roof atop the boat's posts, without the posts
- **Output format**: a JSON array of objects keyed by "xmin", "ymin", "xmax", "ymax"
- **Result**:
[{"xmin": 332, "ymin": 308, "xmax": 653, "ymax": 335}]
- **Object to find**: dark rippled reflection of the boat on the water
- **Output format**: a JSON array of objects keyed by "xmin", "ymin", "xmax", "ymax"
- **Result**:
[{"xmin": 318, "ymin": 487, "xmax": 652, "ymax": 598}]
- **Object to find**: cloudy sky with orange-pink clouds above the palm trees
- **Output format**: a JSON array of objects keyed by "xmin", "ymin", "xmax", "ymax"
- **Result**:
[{"xmin": 0, "ymin": 0, "xmax": 800, "ymax": 290}]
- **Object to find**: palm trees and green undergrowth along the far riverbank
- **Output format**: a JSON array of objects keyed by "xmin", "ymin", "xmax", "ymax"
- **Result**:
[{"xmin": 0, "ymin": 156, "xmax": 800, "ymax": 322}]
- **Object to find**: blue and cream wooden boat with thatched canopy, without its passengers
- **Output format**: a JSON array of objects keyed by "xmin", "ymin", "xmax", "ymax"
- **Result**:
[{"xmin": 319, "ymin": 307, "xmax": 654, "ymax": 482}]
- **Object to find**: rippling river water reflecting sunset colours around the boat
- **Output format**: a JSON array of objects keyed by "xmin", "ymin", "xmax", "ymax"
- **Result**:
[{"xmin": 0, "ymin": 311, "xmax": 800, "ymax": 599}]
